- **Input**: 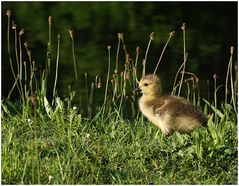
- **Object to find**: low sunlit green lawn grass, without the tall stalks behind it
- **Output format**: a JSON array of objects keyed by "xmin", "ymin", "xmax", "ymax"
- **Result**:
[{"xmin": 2, "ymin": 102, "xmax": 238, "ymax": 184}]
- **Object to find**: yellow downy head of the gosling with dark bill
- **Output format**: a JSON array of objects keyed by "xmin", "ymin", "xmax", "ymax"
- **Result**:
[{"xmin": 138, "ymin": 74, "xmax": 160, "ymax": 96}]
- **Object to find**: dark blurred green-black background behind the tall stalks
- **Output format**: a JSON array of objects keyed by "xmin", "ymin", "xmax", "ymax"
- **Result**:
[{"xmin": 2, "ymin": 2, "xmax": 238, "ymax": 102}]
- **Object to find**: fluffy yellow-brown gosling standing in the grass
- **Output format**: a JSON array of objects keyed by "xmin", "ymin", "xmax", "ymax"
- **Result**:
[{"xmin": 137, "ymin": 75, "xmax": 207, "ymax": 136}]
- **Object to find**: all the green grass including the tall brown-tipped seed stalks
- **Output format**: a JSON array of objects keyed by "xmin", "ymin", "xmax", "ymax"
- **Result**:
[{"xmin": 1, "ymin": 11, "xmax": 238, "ymax": 185}]
